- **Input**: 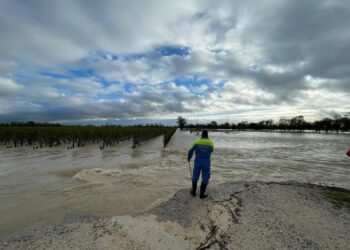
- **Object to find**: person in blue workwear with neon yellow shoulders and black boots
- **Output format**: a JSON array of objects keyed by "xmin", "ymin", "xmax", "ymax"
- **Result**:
[{"xmin": 187, "ymin": 130, "xmax": 214, "ymax": 199}]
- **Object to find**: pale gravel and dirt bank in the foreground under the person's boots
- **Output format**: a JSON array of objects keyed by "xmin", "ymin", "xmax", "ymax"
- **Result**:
[{"xmin": 0, "ymin": 182, "xmax": 350, "ymax": 249}]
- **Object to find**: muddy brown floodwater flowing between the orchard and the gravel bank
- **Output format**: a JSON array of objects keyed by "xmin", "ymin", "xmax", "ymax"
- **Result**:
[{"xmin": 0, "ymin": 131, "xmax": 350, "ymax": 237}]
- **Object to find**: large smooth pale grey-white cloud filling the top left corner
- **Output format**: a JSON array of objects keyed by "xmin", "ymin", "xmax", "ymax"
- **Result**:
[{"xmin": 0, "ymin": 0, "xmax": 196, "ymax": 65}]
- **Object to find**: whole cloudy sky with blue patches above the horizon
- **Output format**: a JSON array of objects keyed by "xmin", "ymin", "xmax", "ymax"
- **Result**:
[{"xmin": 0, "ymin": 0, "xmax": 350, "ymax": 123}]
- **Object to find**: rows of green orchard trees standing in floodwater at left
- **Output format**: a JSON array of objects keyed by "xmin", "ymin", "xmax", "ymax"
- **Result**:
[{"xmin": 0, "ymin": 123, "xmax": 176, "ymax": 149}]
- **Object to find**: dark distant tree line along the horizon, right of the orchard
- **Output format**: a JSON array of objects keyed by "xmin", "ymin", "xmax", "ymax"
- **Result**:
[{"xmin": 182, "ymin": 113, "xmax": 350, "ymax": 133}]
